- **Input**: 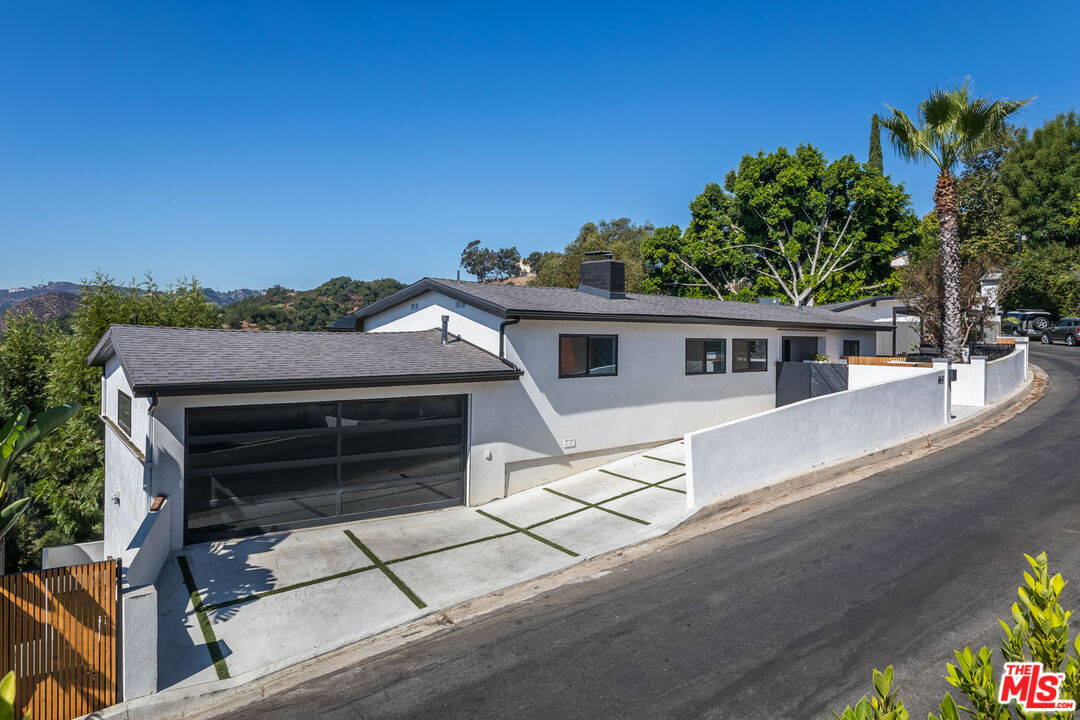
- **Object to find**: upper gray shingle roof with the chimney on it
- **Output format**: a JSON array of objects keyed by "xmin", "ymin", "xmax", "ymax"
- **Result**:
[{"xmin": 332, "ymin": 277, "xmax": 878, "ymax": 330}]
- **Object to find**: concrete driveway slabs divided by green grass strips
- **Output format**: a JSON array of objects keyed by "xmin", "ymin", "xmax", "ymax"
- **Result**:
[{"xmin": 157, "ymin": 441, "xmax": 690, "ymax": 689}]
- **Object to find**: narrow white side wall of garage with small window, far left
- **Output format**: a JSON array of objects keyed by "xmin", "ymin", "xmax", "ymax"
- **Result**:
[{"xmin": 102, "ymin": 357, "xmax": 153, "ymax": 557}]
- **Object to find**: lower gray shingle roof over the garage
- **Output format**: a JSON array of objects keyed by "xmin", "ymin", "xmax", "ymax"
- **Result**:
[{"xmin": 86, "ymin": 325, "xmax": 521, "ymax": 395}]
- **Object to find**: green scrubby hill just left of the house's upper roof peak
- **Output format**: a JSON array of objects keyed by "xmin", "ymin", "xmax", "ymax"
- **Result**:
[{"xmin": 221, "ymin": 276, "xmax": 405, "ymax": 330}]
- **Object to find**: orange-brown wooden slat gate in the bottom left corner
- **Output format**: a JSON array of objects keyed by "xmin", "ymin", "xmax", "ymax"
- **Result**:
[{"xmin": 0, "ymin": 560, "xmax": 120, "ymax": 720}]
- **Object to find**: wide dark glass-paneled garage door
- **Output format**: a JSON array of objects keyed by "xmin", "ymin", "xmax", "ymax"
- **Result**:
[{"xmin": 184, "ymin": 395, "xmax": 467, "ymax": 543}]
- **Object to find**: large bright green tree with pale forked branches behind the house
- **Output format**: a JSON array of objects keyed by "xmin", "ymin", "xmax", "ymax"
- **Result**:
[{"xmin": 645, "ymin": 145, "xmax": 918, "ymax": 305}]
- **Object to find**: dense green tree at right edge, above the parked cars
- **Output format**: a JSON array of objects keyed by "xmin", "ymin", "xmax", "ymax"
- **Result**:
[{"xmin": 1001, "ymin": 111, "xmax": 1080, "ymax": 245}]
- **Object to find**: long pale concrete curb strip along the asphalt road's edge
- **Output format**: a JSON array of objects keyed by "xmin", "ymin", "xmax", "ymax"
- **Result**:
[{"xmin": 85, "ymin": 365, "xmax": 1049, "ymax": 720}]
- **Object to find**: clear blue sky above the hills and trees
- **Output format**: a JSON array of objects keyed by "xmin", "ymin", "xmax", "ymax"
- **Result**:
[{"xmin": 0, "ymin": 0, "xmax": 1080, "ymax": 289}]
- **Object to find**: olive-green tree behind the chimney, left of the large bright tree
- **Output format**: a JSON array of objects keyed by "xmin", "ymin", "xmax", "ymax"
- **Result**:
[{"xmin": 534, "ymin": 218, "xmax": 654, "ymax": 293}]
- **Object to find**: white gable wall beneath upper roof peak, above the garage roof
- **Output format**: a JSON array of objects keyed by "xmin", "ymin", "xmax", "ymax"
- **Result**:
[{"xmin": 364, "ymin": 291, "xmax": 502, "ymax": 354}]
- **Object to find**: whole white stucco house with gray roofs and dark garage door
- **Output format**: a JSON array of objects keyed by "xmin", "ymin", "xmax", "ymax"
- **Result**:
[{"xmin": 89, "ymin": 259, "xmax": 876, "ymax": 557}]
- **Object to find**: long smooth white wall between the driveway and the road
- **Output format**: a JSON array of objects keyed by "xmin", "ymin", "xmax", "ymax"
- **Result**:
[{"xmin": 686, "ymin": 370, "xmax": 946, "ymax": 507}]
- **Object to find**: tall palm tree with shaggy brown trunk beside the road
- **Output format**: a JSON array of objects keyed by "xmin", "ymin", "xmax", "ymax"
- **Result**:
[{"xmin": 880, "ymin": 80, "xmax": 1034, "ymax": 359}]
